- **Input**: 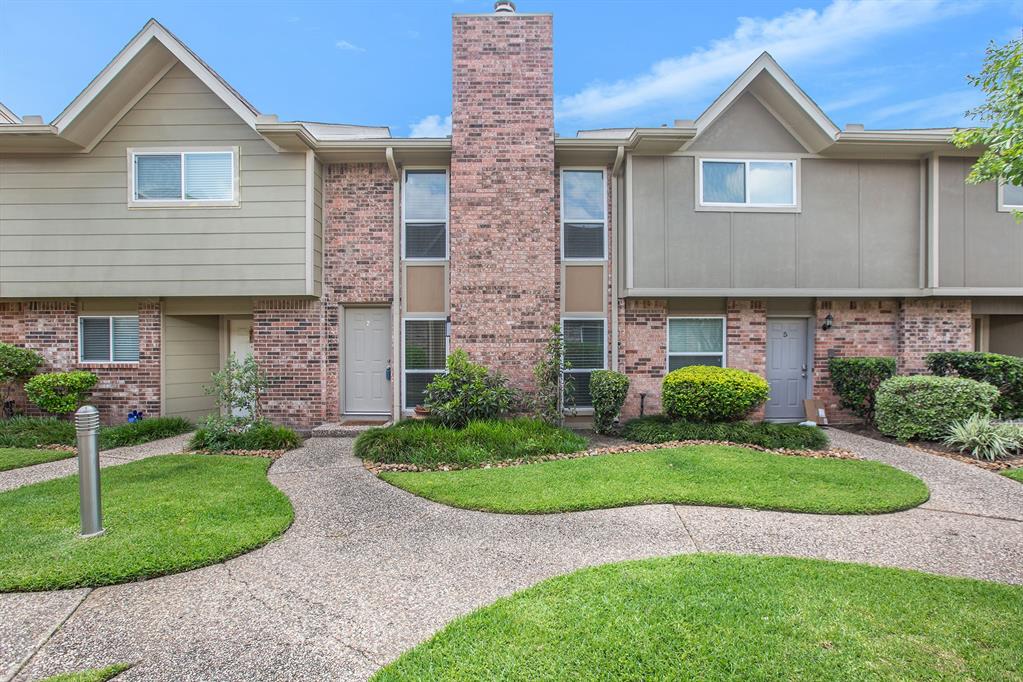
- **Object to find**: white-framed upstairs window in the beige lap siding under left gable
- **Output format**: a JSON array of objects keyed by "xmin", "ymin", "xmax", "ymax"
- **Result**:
[{"xmin": 131, "ymin": 149, "xmax": 236, "ymax": 204}]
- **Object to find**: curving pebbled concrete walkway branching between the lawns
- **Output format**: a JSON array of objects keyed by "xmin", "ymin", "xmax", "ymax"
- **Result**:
[{"xmin": 0, "ymin": 433, "xmax": 1023, "ymax": 681}]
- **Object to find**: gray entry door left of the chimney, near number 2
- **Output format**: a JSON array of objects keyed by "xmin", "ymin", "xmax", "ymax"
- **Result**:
[{"xmin": 341, "ymin": 308, "xmax": 391, "ymax": 414}]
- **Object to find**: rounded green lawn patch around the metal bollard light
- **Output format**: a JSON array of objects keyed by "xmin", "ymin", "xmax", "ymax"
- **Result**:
[{"xmin": 0, "ymin": 455, "xmax": 293, "ymax": 592}]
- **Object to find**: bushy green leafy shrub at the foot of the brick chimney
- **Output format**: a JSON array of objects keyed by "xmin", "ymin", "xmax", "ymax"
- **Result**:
[{"xmin": 424, "ymin": 350, "xmax": 515, "ymax": 428}]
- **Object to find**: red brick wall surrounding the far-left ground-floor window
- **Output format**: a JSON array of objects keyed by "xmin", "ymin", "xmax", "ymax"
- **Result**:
[{"xmin": 0, "ymin": 300, "xmax": 161, "ymax": 423}]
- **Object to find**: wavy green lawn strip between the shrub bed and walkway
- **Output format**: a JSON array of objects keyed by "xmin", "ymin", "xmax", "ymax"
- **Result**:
[{"xmin": 381, "ymin": 446, "xmax": 928, "ymax": 514}]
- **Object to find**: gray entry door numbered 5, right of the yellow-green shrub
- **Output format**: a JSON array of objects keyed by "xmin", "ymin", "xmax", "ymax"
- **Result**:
[{"xmin": 764, "ymin": 318, "xmax": 807, "ymax": 419}]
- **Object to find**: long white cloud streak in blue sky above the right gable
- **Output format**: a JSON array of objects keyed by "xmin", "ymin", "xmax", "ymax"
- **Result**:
[{"xmin": 558, "ymin": 0, "xmax": 976, "ymax": 120}]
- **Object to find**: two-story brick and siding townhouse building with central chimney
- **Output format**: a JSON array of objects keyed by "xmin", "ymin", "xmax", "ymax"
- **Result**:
[{"xmin": 0, "ymin": 2, "xmax": 1023, "ymax": 428}]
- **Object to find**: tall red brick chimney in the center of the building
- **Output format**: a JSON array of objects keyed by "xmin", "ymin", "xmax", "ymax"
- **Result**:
[{"xmin": 449, "ymin": 2, "xmax": 559, "ymax": 388}]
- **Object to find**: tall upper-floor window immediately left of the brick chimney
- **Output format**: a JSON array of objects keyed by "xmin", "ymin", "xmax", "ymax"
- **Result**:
[{"xmin": 401, "ymin": 168, "xmax": 448, "ymax": 261}]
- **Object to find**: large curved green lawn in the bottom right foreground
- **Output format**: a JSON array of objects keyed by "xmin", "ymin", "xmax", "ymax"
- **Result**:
[{"xmin": 374, "ymin": 554, "xmax": 1023, "ymax": 682}]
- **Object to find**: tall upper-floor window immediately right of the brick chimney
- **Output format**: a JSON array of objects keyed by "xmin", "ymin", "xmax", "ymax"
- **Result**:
[{"xmin": 562, "ymin": 168, "xmax": 608, "ymax": 261}]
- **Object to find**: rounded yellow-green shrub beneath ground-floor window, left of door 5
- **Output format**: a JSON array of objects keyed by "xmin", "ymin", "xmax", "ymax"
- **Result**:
[{"xmin": 661, "ymin": 366, "xmax": 769, "ymax": 421}]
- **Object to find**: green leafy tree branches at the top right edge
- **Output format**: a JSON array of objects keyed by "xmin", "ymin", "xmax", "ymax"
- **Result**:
[{"xmin": 951, "ymin": 38, "xmax": 1023, "ymax": 220}]
